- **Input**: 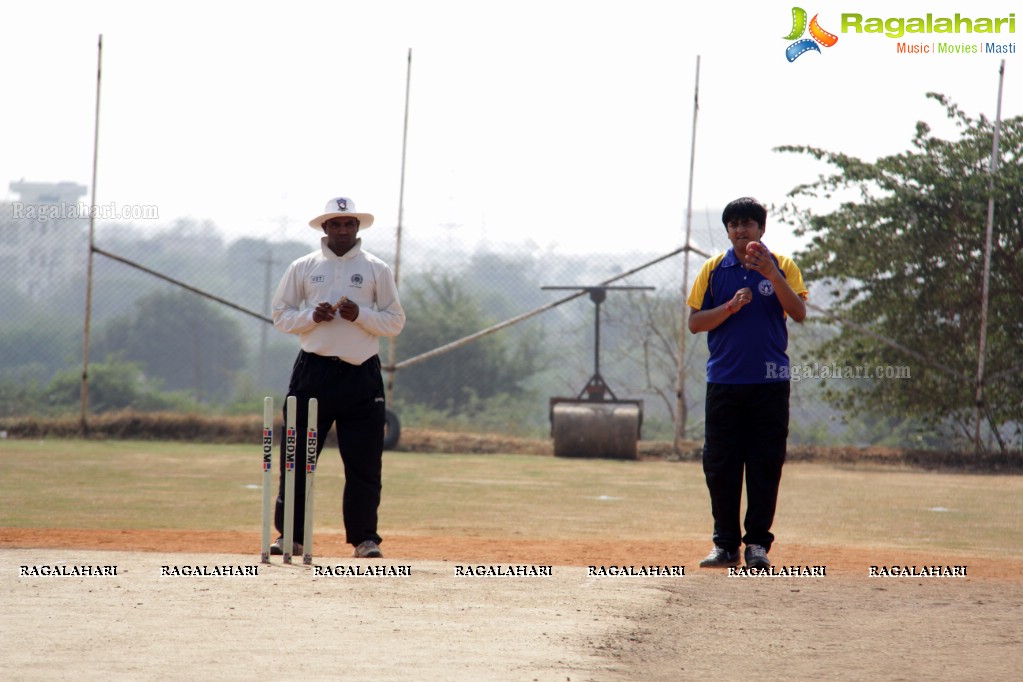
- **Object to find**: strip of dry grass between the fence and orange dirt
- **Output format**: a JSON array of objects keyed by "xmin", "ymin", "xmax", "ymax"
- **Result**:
[{"xmin": 0, "ymin": 440, "xmax": 1023, "ymax": 558}]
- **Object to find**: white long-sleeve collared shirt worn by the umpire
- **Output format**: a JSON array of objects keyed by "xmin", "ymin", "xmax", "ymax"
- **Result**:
[{"xmin": 272, "ymin": 237, "xmax": 405, "ymax": 365}]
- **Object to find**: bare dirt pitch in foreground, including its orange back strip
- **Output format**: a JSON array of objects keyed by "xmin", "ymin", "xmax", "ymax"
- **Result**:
[{"xmin": 0, "ymin": 529, "xmax": 1023, "ymax": 681}]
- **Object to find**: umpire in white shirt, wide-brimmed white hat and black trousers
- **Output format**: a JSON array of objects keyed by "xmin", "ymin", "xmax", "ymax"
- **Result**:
[{"xmin": 271, "ymin": 196, "xmax": 405, "ymax": 557}]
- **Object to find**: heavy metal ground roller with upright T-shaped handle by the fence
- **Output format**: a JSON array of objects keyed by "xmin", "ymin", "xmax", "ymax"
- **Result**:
[{"xmin": 541, "ymin": 285, "xmax": 654, "ymax": 459}]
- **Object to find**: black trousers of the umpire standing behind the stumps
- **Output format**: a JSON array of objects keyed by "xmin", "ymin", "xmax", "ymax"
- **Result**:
[{"xmin": 274, "ymin": 351, "xmax": 386, "ymax": 545}]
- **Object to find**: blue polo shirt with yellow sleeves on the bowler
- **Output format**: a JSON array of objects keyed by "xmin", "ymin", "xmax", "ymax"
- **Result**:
[{"xmin": 686, "ymin": 248, "xmax": 807, "ymax": 383}]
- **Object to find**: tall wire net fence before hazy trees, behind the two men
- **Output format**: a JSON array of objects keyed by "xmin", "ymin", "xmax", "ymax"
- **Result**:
[{"xmin": 0, "ymin": 188, "xmax": 928, "ymax": 446}]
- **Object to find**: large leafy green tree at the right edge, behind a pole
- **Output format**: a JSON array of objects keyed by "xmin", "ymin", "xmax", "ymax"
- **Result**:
[{"xmin": 780, "ymin": 93, "xmax": 1023, "ymax": 449}]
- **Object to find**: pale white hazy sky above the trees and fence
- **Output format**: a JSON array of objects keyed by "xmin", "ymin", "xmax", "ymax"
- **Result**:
[{"xmin": 0, "ymin": 0, "xmax": 1023, "ymax": 258}]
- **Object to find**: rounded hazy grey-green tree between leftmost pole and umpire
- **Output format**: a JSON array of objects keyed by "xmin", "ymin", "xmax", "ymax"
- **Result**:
[{"xmin": 95, "ymin": 291, "xmax": 246, "ymax": 403}]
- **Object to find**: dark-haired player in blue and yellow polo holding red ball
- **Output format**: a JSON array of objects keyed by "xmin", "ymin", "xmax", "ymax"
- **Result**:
[{"xmin": 687, "ymin": 197, "xmax": 807, "ymax": 569}]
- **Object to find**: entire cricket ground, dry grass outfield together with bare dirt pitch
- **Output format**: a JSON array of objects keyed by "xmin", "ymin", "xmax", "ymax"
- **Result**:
[{"xmin": 0, "ymin": 440, "xmax": 1023, "ymax": 682}]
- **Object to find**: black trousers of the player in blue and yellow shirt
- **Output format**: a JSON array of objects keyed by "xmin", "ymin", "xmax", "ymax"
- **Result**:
[{"xmin": 703, "ymin": 381, "xmax": 790, "ymax": 551}]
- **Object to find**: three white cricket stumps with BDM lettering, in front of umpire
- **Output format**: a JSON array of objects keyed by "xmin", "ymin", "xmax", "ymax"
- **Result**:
[{"xmin": 260, "ymin": 396, "xmax": 319, "ymax": 564}]
